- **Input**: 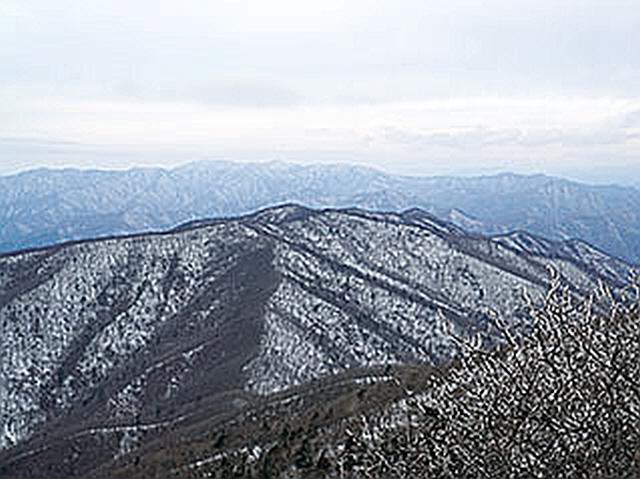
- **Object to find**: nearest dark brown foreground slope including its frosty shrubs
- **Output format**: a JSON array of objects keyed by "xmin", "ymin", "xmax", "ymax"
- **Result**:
[{"xmin": 87, "ymin": 284, "xmax": 640, "ymax": 479}]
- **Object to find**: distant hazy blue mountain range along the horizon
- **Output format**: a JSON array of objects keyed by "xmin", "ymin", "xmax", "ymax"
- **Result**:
[{"xmin": 0, "ymin": 162, "xmax": 640, "ymax": 263}]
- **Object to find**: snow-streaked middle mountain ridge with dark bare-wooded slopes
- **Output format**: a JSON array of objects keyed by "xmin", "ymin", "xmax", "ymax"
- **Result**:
[{"xmin": 0, "ymin": 205, "xmax": 632, "ymax": 478}]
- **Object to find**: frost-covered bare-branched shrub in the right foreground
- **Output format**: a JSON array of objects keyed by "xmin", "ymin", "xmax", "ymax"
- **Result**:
[{"xmin": 336, "ymin": 274, "xmax": 640, "ymax": 478}]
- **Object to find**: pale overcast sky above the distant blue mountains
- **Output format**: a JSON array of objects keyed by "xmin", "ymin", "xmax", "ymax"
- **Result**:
[{"xmin": 0, "ymin": 0, "xmax": 640, "ymax": 182}]
